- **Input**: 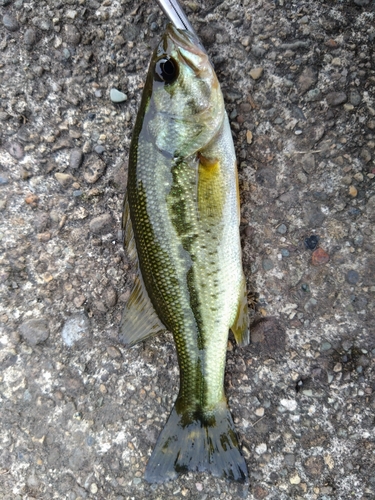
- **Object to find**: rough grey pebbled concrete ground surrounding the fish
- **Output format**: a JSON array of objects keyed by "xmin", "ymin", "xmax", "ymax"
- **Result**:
[{"xmin": 0, "ymin": 0, "xmax": 375, "ymax": 500}]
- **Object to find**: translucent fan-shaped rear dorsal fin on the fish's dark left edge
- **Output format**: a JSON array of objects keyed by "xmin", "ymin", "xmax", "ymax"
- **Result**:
[{"xmin": 120, "ymin": 276, "xmax": 166, "ymax": 347}]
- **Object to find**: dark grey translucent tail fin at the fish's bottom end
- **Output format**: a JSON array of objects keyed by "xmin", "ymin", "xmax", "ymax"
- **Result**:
[{"xmin": 145, "ymin": 403, "xmax": 248, "ymax": 483}]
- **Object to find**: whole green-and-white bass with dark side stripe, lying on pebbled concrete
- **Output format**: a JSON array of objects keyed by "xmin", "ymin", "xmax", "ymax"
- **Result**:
[{"xmin": 119, "ymin": 24, "xmax": 249, "ymax": 483}]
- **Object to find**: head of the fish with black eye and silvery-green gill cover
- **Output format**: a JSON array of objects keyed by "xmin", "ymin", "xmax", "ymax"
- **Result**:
[{"xmin": 147, "ymin": 24, "xmax": 225, "ymax": 157}]
